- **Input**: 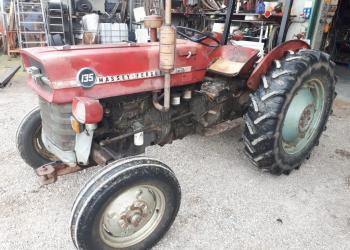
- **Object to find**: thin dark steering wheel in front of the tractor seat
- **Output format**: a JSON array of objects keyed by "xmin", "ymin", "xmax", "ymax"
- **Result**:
[{"xmin": 176, "ymin": 26, "xmax": 220, "ymax": 48}]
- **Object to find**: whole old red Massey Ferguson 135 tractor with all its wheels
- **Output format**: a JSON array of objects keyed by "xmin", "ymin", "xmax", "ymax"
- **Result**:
[{"xmin": 17, "ymin": 1, "xmax": 336, "ymax": 249}]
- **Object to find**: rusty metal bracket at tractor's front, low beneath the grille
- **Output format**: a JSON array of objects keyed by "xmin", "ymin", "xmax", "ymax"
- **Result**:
[{"xmin": 35, "ymin": 162, "xmax": 81, "ymax": 185}]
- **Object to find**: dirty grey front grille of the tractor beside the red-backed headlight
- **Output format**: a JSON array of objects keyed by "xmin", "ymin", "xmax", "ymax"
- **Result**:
[{"xmin": 39, "ymin": 98, "xmax": 75, "ymax": 151}]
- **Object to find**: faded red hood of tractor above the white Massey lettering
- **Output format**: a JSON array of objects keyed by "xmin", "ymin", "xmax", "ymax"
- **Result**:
[{"xmin": 21, "ymin": 40, "xmax": 209, "ymax": 89}]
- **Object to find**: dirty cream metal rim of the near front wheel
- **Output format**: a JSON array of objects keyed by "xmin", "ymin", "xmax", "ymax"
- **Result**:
[{"xmin": 99, "ymin": 185, "xmax": 165, "ymax": 248}]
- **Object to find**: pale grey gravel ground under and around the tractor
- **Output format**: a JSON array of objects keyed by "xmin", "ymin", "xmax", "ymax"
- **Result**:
[{"xmin": 0, "ymin": 55, "xmax": 350, "ymax": 250}]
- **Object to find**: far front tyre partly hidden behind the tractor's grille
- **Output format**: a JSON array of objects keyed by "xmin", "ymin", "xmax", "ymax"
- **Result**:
[{"xmin": 16, "ymin": 107, "xmax": 54, "ymax": 169}]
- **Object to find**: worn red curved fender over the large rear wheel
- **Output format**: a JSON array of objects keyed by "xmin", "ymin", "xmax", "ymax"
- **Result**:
[{"xmin": 247, "ymin": 40, "xmax": 310, "ymax": 90}]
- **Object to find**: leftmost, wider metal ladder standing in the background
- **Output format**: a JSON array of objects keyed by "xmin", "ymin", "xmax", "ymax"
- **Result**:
[{"xmin": 15, "ymin": 0, "xmax": 48, "ymax": 49}]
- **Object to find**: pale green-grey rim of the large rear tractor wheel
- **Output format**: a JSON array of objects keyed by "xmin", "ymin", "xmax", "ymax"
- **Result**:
[{"xmin": 282, "ymin": 79, "xmax": 325, "ymax": 154}]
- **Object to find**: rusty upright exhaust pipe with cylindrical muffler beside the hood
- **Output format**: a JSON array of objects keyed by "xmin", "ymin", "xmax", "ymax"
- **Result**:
[{"xmin": 153, "ymin": 0, "xmax": 176, "ymax": 112}]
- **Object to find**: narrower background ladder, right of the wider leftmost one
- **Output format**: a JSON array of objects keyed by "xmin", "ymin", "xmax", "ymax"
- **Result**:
[{"xmin": 46, "ymin": 1, "xmax": 67, "ymax": 45}]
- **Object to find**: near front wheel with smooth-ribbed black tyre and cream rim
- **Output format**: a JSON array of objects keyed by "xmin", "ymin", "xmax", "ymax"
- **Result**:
[{"xmin": 71, "ymin": 157, "xmax": 181, "ymax": 250}]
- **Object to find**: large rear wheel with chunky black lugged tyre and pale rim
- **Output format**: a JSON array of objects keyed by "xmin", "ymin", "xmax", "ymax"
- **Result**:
[{"xmin": 243, "ymin": 49, "xmax": 336, "ymax": 175}]
